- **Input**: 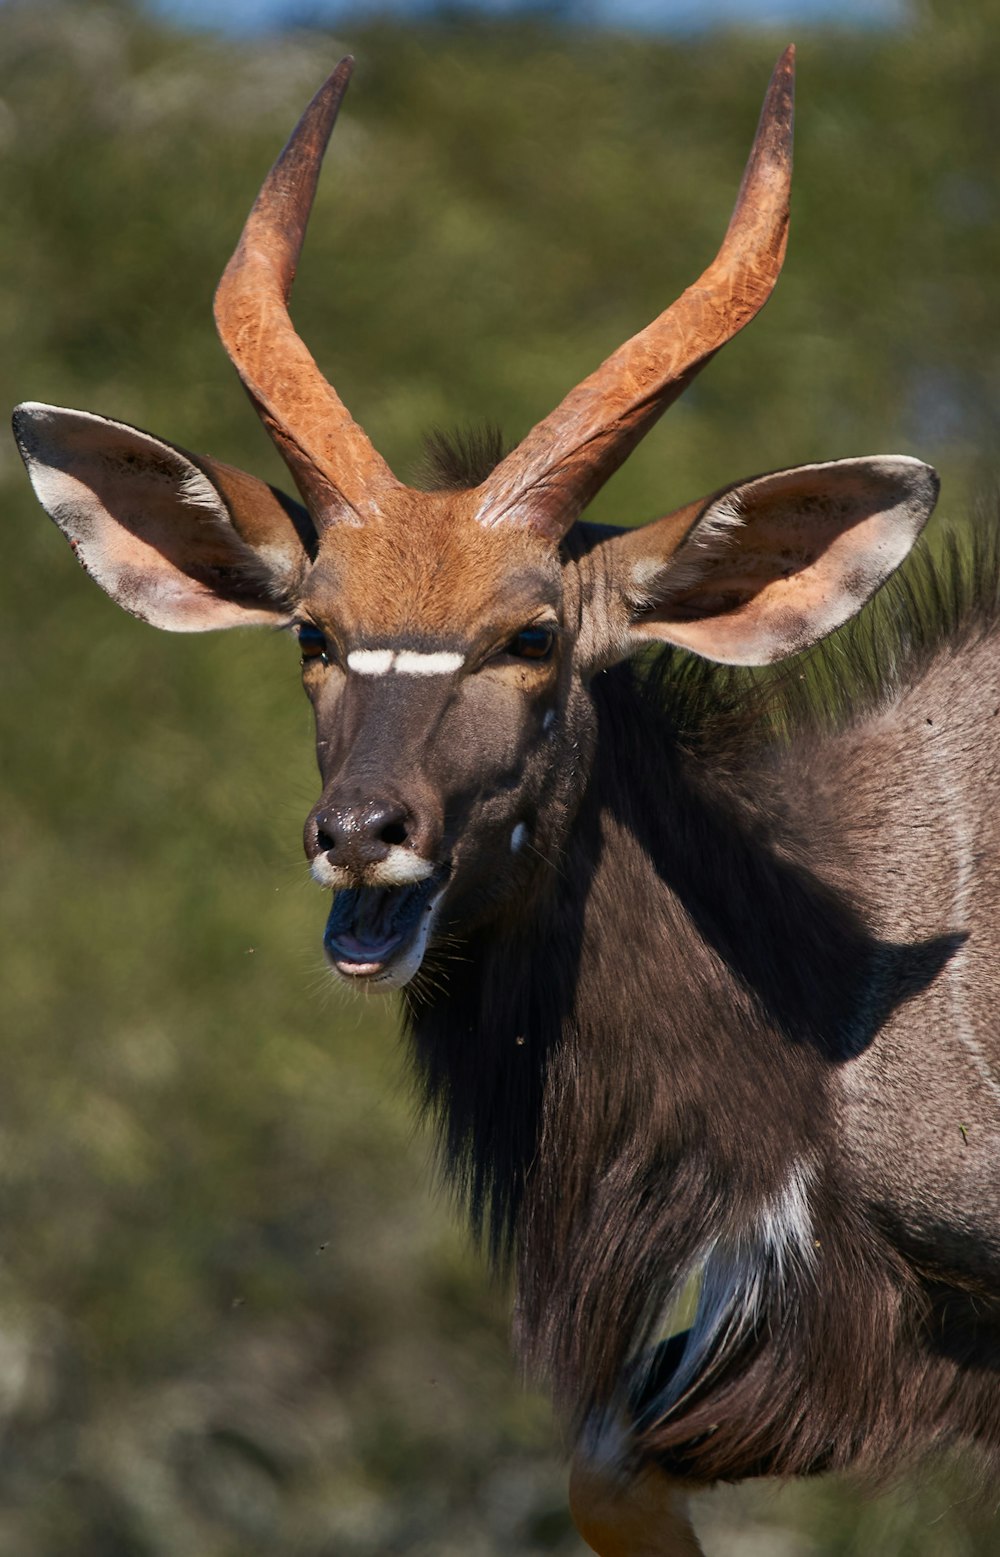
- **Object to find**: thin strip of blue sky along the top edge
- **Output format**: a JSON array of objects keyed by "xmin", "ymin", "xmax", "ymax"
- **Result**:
[{"xmin": 146, "ymin": 0, "xmax": 907, "ymax": 33}]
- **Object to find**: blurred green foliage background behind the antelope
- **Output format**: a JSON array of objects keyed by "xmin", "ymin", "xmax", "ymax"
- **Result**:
[{"xmin": 0, "ymin": 0, "xmax": 1000, "ymax": 1557}]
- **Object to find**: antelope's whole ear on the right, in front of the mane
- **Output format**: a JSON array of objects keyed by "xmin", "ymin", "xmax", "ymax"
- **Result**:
[{"xmin": 585, "ymin": 455, "xmax": 939, "ymax": 665}]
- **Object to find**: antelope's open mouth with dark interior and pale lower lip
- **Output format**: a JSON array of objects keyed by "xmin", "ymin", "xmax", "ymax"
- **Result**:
[{"xmin": 322, "ymin": 869, "xmax": 447, "ymax": 989}]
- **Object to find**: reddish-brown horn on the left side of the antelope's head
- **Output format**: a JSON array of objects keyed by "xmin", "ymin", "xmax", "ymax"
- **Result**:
[{"xmin": 215, "ymin": 56, "xmax": 400, "ymax": 528}]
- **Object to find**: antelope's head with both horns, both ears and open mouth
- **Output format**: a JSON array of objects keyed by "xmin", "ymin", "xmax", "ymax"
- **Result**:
[{"xmin": 14, "ymin": 50, "xmax": 936, "ymax": 989}]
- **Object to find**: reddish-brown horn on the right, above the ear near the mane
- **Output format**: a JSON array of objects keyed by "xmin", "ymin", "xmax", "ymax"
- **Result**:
[{"xmin": 478, "ymin": 47, "xmax": 794, "ymax": 542}]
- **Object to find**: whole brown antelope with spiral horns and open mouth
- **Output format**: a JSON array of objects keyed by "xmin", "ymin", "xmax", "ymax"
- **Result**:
[{"xmin": 14, "ymin": 48, "xmax": 1000, "ymax": 1557}]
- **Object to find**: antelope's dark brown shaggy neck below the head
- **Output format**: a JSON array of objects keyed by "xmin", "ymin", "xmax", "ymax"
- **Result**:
[{"xmin": 398, "ymin": 671, "xmax": 934, "ymax": 1444}]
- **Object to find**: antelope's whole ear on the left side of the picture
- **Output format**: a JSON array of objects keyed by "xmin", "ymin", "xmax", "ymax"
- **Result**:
[{"xmin": 14, "ymin": 403, "xmax": 315, "ymax": 632}]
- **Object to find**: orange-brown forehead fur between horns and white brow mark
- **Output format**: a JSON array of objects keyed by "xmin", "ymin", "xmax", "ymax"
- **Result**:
[{"xmin": 302, "ymin": 492, "xmax": 561, "ymax": 640}]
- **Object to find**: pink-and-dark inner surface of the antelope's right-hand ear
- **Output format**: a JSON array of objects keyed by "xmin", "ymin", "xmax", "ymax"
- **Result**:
[{"xmin": 634, "ymin": 456, "xmax": 936, "ymax": 665}]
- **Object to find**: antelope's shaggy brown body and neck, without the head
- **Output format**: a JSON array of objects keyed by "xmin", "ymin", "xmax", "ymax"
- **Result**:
[{"xmin": 408, "ymin": 541, "xmax": 1000, "ymax": 1481}]
